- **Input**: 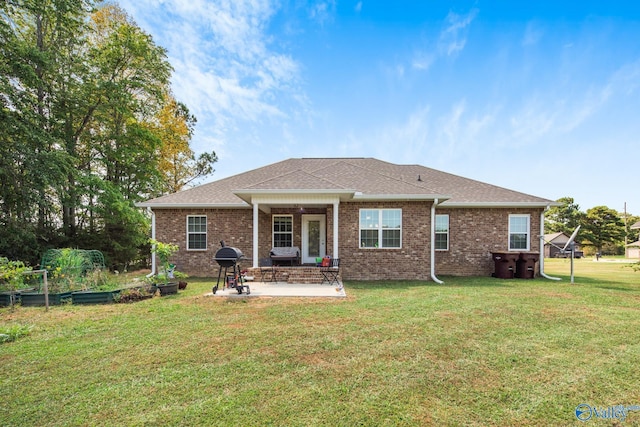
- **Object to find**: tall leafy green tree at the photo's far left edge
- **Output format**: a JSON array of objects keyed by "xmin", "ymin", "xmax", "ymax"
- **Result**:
[{"xmin": 0, "ymin": 0, "xmax": 93, "ymax": 260}]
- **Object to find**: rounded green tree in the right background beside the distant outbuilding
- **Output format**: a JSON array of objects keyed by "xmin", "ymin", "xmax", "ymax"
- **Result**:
[{"xmin": 580, "ymin": 206, "xmax": 625, "ymax": 253}]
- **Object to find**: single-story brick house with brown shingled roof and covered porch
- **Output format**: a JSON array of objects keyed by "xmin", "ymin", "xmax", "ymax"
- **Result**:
[{"xmin": 139, "ymin": 158, "xmax": 555, "ymax": 281}]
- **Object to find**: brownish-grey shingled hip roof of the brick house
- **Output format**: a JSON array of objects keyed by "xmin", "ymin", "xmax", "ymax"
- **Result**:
[{"xmin": 139, "ymin": 158, "xmax": 555, "ymax": 208}]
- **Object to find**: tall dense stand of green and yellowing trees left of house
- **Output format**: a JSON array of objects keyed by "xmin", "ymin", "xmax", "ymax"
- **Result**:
[{"xmin": 0, "ymin": 0, "xmax": 217, "ymax": 268}]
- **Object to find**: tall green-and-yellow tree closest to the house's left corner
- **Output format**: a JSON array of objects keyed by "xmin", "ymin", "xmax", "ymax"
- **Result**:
[{"xmin": 81, "ymin": 5, "xmax": 171, "ymax": 268}]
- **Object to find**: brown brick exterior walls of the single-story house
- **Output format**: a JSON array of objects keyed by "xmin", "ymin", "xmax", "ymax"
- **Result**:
[{"xmin": 154, "ymin": 202, "xmax": 541, "ymax": 280}]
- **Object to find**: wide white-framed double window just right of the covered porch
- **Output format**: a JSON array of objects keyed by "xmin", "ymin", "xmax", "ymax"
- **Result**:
[{"xmin": 360, "ymin": 209, "xmax": 402, "ymax": 248}]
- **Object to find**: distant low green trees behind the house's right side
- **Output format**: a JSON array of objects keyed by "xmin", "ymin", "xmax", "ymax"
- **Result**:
[{"xmin": 544, "ymin": 197, "xmax": 640, "ymax": 255}]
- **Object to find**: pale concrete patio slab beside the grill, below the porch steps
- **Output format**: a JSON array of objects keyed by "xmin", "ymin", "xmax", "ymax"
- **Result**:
[{"xmin": 205, "ymin": 281, "xmax": 347, "ymax": 298}]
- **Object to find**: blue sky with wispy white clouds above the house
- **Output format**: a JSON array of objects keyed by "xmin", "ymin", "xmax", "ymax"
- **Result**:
[{"xmin": 119, "ymin": 0, "xmax": 640, "ymax": 215}]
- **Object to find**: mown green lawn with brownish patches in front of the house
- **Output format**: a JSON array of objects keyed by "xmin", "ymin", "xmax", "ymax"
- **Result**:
[{"xmin": 0, "ymin": 259, "xmax": 640, "ymax": 426}]
